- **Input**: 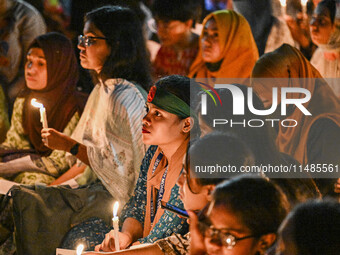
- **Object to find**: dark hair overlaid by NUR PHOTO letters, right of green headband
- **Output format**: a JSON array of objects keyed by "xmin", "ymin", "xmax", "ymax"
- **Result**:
[{"xmin": 196, "ymin": 84, "xmax": 281, "ymax": 164}]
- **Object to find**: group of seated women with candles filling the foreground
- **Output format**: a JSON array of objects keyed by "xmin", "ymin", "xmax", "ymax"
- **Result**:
[{"xmin": 0, "ymin": 0, "xmax": 340, "ymax": 255}]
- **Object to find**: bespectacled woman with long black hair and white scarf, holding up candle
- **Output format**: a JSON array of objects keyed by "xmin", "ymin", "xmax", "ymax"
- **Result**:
[{"xmin": 42, "ymin": 6, "xmax": 151, "ymax": 205}]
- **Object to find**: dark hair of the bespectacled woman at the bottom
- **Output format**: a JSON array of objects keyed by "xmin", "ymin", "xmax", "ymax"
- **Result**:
[{"xmin": 213, "ymin": 175, "xmax": 289, "ymax": 237}]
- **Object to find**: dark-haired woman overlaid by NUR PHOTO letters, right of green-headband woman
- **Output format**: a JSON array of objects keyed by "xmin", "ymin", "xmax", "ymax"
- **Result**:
[{"xmin": 196, "ymin": 84, "xmax": 320, "ymax": 206}]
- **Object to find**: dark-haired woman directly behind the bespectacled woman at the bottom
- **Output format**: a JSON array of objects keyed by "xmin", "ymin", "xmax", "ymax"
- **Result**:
[{"xmin": 85, "ymin": 132, "xmax": 254, "ymax": 255}]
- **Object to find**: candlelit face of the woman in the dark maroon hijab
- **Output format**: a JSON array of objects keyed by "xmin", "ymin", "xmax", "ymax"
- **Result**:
[{"xmin": 25, "ymin": 48, "xmax": 47, "ymax": 90}]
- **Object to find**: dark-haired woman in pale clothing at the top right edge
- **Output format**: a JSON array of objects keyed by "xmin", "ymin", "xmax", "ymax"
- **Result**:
[{"xmin": 310, "ymin": 0, "xmax": 340, "ymax": 97}]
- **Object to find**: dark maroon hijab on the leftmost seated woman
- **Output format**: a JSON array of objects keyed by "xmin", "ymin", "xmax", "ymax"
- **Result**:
[{"xmin": 23, "ymin": 32, "xmax": 80, "ymax": 156}]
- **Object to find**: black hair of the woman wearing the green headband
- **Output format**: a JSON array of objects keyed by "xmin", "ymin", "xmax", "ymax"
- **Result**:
[{"xmin": 155, "ymin": 75, "xmax": 200, "ymax": 137}]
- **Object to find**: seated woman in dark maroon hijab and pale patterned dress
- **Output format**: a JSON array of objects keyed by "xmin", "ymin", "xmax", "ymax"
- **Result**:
[{"xmin": 0, "ymin": 33, "xmax": 86, "ymax": 184}]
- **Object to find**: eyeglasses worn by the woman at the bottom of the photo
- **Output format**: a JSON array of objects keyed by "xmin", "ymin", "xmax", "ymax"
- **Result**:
[{"xmin": 198, "ymin": 221, "xmax": 256, "ymax": 249}]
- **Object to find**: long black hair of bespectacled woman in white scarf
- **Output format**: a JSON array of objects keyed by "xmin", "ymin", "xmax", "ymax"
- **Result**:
[{"xmin": 84, "ymin": 6, "xmax": 151, "ymax": 90}]
